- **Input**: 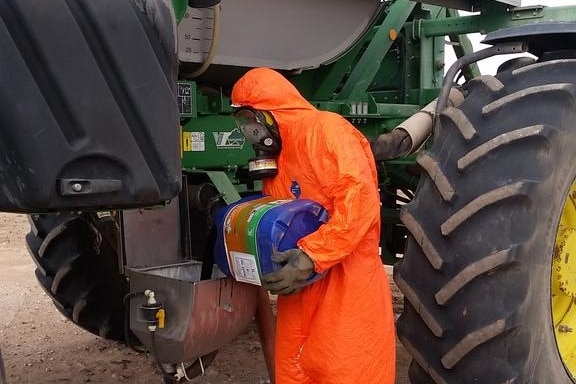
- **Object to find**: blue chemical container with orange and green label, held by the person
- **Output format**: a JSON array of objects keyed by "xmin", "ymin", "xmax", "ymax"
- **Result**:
[{"xmin": 214, "ymin": 195, "xmax": 328, "ymax": 285}]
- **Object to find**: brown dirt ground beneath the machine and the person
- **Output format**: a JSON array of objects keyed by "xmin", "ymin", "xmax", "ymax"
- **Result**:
[{"xmin": 0, "ymin": 213, "xmax": 410, "ymax": 384}]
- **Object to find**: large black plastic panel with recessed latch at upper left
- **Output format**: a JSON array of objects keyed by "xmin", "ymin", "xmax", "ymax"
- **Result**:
[{"xmin": 0, "ymin": 0, "xmax": 181, "ymax": 212}]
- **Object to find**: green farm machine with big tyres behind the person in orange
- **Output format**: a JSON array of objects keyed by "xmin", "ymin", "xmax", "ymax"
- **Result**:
[{"xmin": 0, "ymin": 0, "xmax": 576, "ymax": 384}]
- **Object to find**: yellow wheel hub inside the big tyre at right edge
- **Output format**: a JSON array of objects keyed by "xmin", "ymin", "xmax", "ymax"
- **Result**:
[{"xmin": 552, "ymin": 183, "xmax": 576, "ymax": 377}]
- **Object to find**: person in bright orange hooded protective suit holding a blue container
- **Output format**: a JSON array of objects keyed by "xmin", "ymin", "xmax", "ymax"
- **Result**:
[{"xmin": 232, "ymin": 68, "xmax": 396, "ymax": 384}]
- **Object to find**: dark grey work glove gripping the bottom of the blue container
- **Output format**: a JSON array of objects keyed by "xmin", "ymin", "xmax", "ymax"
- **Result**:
[{"xmin": 262, "ymin": 249, "xmax": 314, "ymax": 295}]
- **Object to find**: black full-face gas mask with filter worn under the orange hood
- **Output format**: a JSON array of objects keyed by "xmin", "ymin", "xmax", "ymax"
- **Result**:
[{"xmin": 234, "ymin": 107, "xmax": 282, "ymax": 180}]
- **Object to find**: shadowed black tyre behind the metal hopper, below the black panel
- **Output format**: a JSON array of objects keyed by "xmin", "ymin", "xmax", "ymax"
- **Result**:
[{"xmin": 26, "ymin": 214, "xmax": 129, "ymax": 341}]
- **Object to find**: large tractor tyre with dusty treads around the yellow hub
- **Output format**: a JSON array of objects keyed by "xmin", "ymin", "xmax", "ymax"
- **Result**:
[{"xmin": 394, "ymin": 59, "xmax": 576, "ymax": 384}]
